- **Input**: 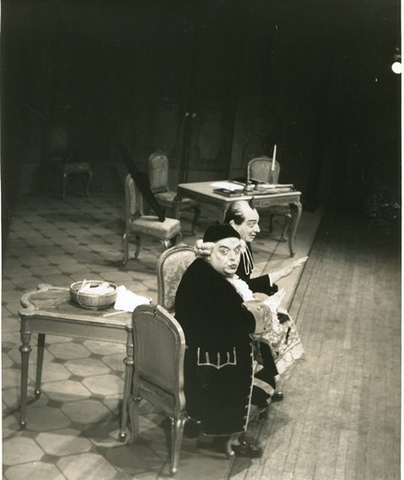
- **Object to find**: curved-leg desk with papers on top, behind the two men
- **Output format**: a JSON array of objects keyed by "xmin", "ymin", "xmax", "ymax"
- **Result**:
[{"xmin": 176, "ymin": 180, "xmax": 302, "ymax": 257}]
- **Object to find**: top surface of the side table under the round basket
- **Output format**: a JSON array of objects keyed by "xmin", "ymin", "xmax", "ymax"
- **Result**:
[{"xmin": 19, "ymin": 284, "xmax": 132, "ymax": 328}]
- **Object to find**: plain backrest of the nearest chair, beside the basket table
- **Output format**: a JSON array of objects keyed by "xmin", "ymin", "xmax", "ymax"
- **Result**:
[{"xmin": 132, "ymin": 304, "xmax": 185, "ymax": 412}]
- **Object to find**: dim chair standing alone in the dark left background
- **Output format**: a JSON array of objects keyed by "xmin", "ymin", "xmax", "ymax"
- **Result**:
[{"xmin": 46, "ymin": 124, "xmax": 93, "ymax": 198}]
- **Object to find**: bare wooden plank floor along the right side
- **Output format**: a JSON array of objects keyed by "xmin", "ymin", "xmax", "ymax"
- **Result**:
[{"xmin": 228, "ymin": 214, "xmax": 401, "ymax": 480}]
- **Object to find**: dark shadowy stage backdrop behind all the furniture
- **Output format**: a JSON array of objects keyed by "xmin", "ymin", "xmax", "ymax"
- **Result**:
[{"xmin": 1, "ymin": 0, "xmax": 401, "ymax": 238}]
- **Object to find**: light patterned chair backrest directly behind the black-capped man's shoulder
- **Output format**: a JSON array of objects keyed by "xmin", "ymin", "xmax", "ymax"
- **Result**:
[{"xmin": 157, "ymin": 244, "xmax": 196, "ymax": 313}]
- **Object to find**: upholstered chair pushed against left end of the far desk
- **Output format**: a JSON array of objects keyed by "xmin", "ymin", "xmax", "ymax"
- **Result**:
[{"xmin": 147, "ymin": 151, "xmax": 201, "ymax": 235}]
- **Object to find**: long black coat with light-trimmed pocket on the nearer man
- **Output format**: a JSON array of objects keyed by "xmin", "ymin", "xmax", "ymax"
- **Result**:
[{"xmin": 175, "ymin": 259, "xmax": 255, "ymax": 435}]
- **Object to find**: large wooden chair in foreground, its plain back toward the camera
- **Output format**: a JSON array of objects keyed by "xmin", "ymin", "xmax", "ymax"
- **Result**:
[{"xmin": 128, "ymin": 305, "xmax": 186, "ymax": 475}]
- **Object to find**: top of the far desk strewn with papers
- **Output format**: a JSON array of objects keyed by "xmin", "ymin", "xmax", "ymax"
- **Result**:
[{"xmin": 177, "ymin": 180, "xmax": 301, "ymax": 203}]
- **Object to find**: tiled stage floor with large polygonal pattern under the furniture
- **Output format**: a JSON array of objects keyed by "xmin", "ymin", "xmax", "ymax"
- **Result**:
[{"xmin": 2, "ymin": 195, "xmax": 318, "ymax": 480}]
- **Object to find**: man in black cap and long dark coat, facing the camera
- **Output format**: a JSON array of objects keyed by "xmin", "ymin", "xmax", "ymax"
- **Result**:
[{"xmin": 175, "ymin": 225, "xmax": 271, "ymax": 457}]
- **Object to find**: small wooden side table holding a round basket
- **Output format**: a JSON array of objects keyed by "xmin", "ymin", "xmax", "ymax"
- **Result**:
[{"xmin": 19, "ymin": 284, "xmax": 133, "ymax": 441}]
